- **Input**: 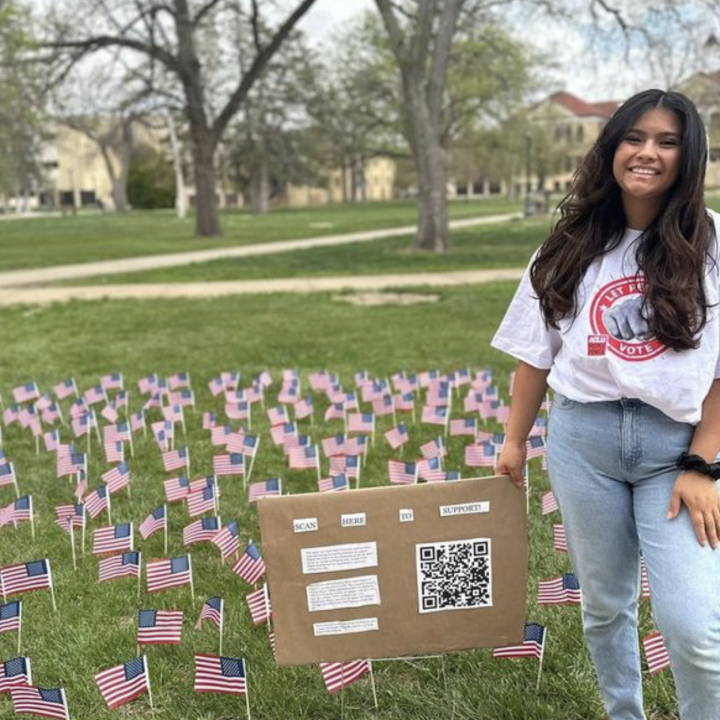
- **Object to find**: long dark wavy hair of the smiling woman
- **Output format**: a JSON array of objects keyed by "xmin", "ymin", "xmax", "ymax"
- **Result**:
[{"xmin": 530, "ymin": 90, "xmax": 714, "ymax": 350}]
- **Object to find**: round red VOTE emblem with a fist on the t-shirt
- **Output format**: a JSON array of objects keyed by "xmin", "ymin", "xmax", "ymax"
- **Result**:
[{"xmin": 588, "ymin": 275, "xmax": 667, "ymax": 362}]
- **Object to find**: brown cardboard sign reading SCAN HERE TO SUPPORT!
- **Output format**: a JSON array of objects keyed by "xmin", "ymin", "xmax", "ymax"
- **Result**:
[{"xmin": 258, "ymin": 476, "xmax": 527, "ymax": 665}]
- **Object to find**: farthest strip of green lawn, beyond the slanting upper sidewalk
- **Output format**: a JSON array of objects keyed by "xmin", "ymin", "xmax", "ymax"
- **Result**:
[{"xmin": 0, "ymin": 198, "xmax": 521, "ymax": 272}]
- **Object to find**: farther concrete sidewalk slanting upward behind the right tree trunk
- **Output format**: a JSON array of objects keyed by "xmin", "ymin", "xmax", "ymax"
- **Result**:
[{"xmin": 0, "ymin": 213, "xmax": 522, "ymax": 288}]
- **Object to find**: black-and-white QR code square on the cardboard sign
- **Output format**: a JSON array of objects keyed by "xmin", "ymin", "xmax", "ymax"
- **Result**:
[{"xmin": 415, "ymin": 538, "xmax": 492, "ymax": 613}]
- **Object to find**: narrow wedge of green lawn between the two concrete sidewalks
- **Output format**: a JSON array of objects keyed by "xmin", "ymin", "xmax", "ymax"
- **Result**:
[{"xmin": 64, "ymin": 219, "xmax": 549, "ymax": 285}]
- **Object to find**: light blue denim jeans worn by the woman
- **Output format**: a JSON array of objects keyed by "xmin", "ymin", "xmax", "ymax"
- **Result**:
[{"xmin": 548, "ymin": 394, "xmax": 720, "ymax": 720}]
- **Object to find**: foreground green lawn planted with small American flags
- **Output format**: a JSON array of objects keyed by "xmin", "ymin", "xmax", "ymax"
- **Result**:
[{"xmin": 0, "ymin": 284, "xmax": 676, "ymax": 720}]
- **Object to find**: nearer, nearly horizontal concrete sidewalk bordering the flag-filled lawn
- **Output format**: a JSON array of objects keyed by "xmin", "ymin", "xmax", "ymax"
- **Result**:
[{"xmin": 0, "ymin": 268, "xmax": 523, "ymax": 306}]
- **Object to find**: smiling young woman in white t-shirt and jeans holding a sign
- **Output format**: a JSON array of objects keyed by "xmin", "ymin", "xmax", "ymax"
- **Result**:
[{"xmin": 492, "ymin": 90, "xmax": 720, "ymax": 720}]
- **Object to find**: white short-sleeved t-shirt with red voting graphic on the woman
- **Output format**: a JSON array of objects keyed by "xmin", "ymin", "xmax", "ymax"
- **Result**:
[{"xmin": 492, "ymin": 211, "xmax": 720, "ymax": 425}]
